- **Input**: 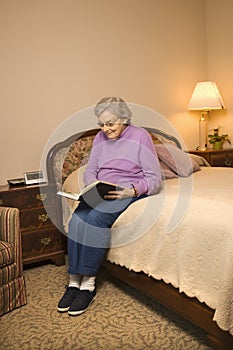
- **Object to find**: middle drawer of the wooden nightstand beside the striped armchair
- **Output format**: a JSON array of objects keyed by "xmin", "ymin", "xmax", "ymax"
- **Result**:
[{"xmin": 19, "ymin": 207, "xmax": 56, "ymax": 232}]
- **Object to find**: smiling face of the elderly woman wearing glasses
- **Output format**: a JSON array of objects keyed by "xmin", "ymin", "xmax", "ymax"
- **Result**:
[{"xmin": 98, "ymin": 110, "xmax": 127, "ymax": 139}]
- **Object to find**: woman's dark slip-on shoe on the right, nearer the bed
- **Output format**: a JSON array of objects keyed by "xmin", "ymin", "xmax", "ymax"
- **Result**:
[{"xmin": 68, "ymin": 290, "xmax": 96, "ymax": 316}]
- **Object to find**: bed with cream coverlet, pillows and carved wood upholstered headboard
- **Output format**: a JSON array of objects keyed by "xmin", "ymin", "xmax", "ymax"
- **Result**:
[{"xmin": 46, "ymin": 127, "xmax": 233, "ymax": 349}]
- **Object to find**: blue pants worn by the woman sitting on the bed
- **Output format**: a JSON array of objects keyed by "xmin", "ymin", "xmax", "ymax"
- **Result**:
[{"xmin": 68, "ymin": 195, "xmax": 147, "ymax": 276}]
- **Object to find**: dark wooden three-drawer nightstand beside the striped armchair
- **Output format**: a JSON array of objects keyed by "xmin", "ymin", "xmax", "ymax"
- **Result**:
[{"xmin": 0, "ymin": 184, "xmax": 65, "ymax": 266}]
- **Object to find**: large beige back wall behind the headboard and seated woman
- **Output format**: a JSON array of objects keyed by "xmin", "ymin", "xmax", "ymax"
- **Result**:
[{"xmin": 0, "ymin": 0, "xmax": 210, "ymax": 183}]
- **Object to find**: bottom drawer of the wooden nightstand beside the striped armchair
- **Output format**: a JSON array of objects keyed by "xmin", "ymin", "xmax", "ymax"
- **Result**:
[{"xmin": 22, "ymin": 227, "xmax": 61, "ymax": 259}]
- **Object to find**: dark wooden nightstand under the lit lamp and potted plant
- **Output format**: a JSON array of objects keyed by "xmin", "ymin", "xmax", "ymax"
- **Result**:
[{"xmin": 189, "ymin": 148, "xmax": 233, "ymax": 168}]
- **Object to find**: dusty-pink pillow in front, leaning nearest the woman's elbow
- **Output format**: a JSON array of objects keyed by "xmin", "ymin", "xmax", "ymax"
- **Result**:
[{"xmin": 155, "ymin": 144, "xmax": 200, "ymax": 177}]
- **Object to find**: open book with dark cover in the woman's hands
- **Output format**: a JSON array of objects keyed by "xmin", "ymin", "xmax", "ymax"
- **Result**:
[{"xmin": 57, "ymin": 181, "xmax": 123, "ymax": 204}]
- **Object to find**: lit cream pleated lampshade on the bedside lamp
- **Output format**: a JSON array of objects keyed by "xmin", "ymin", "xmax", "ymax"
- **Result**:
[{"xmin": 188, "ymin": 81, "xmax": 225, "ymax": 111}]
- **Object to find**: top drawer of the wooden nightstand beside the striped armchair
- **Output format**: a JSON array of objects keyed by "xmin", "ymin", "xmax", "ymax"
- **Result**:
[{"xmin": 0, "ymin": 186, "xmax": 56, "ymax": 210}]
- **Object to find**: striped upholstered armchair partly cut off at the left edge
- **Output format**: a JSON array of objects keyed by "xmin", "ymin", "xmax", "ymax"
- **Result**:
[{"xmin": 0, "ymin": 207, "xmax": 26, "ymax": 316}]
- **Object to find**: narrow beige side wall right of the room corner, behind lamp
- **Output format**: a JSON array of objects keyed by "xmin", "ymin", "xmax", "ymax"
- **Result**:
[{"xmin": 206, "ymin": 0, "xmax": 233, "ymax": 136}]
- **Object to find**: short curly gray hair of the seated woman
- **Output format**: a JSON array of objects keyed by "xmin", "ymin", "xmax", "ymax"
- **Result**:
[{"xmin": 94, "ymin": 96, "xmax": 132, "ymax": 124}]
